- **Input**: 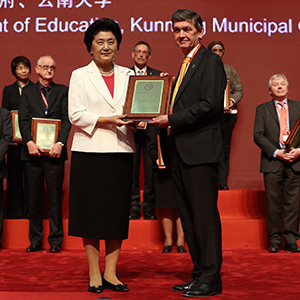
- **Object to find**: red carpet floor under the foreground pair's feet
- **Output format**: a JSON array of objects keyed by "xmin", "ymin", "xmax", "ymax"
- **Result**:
[{"xmin": 0, "ymin": 249, "xmax": 300, "ymax": 300}]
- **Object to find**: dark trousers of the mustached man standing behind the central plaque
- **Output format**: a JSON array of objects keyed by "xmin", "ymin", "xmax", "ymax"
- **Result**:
[{"xmin": 131, "ymin": 129, "xmax": 155, "ymax": 212}]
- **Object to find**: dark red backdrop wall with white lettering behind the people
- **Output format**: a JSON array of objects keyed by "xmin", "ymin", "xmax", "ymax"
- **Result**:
[{"xmin": 0, "ymin": 0, "xmax": 300, "ymax": 188}]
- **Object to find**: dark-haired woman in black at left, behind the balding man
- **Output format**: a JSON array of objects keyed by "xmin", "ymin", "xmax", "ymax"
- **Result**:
[{"xmin": 2, "ymin": 56, "xmax": 33, "ymax": 219}]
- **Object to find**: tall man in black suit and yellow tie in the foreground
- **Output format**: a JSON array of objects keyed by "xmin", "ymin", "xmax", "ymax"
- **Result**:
[{"xmin": 150, "ymin": 9, "xmax": 226, "ymax": 297}]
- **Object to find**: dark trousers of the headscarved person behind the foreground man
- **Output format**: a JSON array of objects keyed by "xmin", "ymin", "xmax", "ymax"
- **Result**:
[{"xmin": 219, "ymin": 113, "xmax": 237, "ymax": 186}]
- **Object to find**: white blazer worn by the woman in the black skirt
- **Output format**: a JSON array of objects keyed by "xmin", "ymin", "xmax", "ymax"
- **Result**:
[{"xmin": 69, "ymin": 61, "xmax": 135, "ymax": 153}]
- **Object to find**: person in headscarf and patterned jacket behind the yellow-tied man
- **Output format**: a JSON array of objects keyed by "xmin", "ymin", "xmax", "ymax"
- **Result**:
[{"xmin": 207, "ymin": 41, "xmax": 243, "ymax": 190}]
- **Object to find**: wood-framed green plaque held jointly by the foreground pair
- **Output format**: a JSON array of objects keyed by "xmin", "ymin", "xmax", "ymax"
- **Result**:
[{"xmin": 123, "ymin": 76, "xmax": 172, "ymax": 121}]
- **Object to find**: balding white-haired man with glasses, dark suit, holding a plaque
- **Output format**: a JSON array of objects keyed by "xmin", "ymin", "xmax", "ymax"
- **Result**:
[{"xmin": 19, "ymin": 56, "xmax": 71, "ymax": 253}]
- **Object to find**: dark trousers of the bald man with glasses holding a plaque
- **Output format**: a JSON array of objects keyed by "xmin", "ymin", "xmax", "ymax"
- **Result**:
[{"xmin": 24, "ymin": 157, "xmax": 65, "ymax": 246}]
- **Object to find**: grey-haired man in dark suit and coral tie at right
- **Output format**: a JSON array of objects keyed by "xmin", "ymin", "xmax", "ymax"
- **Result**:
[{"xmin": 254, "ymin": 74, "xmax": 300, "ymax": 253}]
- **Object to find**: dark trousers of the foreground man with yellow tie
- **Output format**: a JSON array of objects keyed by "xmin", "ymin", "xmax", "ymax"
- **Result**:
[{"xmin": 172, "ymin": 151, "xmax": 222, "ymax": 284}]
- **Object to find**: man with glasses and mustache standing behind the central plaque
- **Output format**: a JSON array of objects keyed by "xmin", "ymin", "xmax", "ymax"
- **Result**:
[{"xmin": 130, "ymin": 41, "xmax": 161, "ymax": 220}]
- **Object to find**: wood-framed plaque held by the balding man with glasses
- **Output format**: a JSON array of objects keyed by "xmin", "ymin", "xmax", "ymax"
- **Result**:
[{"xmin": 31, "ymin": 118, "xmax": 61, "ymax": 155}]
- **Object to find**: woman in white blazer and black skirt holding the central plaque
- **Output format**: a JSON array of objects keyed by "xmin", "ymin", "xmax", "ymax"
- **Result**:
[{"xmin": 69, "ymin": 18, "xmax": 135, "ymax": 293}]
